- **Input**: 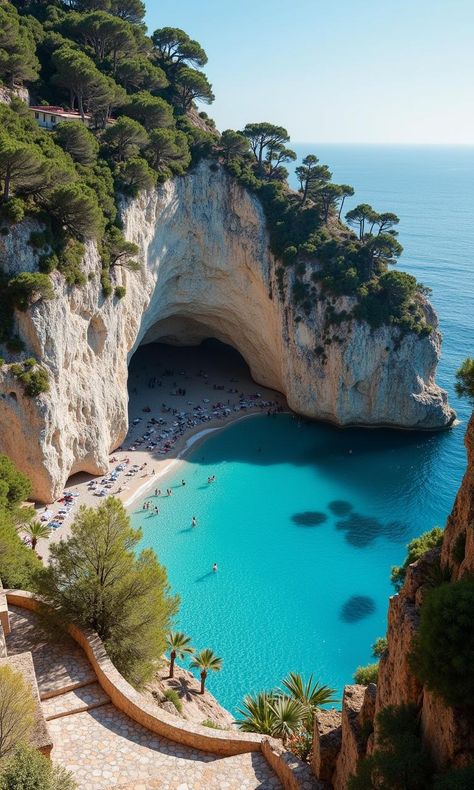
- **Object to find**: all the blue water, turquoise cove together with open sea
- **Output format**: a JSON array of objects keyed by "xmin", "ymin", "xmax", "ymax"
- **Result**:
[{"xmin": 132, "ymin": 145, "xmax": 474, "ymax": 709}]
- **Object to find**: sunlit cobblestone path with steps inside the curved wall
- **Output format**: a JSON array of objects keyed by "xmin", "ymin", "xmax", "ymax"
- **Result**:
[{"xmin": 7, "ymin": 607, "xmax": 281, "ymax": 790}]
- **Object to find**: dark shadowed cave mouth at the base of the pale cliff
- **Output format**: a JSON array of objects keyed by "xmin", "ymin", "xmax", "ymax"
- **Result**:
[{"xmin": 123, "ymin": 316, "xmax": 284, "ymax": 457}]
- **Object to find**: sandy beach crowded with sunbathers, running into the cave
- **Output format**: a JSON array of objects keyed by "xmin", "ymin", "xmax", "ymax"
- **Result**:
[{"xmin": 37, "ymin": 343, "xmax": 288, "ymax": 561}]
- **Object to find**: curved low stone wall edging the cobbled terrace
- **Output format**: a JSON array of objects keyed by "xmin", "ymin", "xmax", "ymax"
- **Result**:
[{"xmin": 5, "ymin": 590, "xmax": 322, "ymax": 790}]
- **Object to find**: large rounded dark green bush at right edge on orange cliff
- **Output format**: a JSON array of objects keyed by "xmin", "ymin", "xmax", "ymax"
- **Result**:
[{"xmin": 410, "ymin": 578, "xmax": 474, "ymax": 706}]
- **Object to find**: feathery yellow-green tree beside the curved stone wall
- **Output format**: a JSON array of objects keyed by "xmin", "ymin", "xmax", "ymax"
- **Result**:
[{"xmin": 40, "ymin": 497, "xmax": 178, "ymax": 685}]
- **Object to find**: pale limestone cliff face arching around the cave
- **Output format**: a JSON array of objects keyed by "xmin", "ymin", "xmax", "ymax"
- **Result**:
[{"xmin": 0, "ymin": 162, "xmax": 454, "ymax": 501}]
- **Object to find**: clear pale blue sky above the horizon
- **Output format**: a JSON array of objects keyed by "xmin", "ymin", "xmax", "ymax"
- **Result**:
[{"xmin": 145, "ymin": 0, "xmax": 474, "ymax": 144}]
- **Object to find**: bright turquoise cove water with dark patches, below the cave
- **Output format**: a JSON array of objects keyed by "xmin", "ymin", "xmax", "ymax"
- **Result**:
[{"xmin": 132, "ymin": 414, "xmax": 453, "ymax": 712}]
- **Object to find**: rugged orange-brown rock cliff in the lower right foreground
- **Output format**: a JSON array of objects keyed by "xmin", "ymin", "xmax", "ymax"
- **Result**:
[{"xmin": 312, "ymin": 415, "xmax": 474, "ymax": 790}]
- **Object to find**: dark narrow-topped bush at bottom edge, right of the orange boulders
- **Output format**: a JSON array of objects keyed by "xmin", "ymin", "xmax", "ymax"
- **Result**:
[{"xmin": 347, "ymin": 705, "xmax": 432, "ymax": 790}]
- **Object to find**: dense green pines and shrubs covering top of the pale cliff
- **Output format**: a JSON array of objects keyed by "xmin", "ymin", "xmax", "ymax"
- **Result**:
[{"xmin": 0, "ymin": 0, "xmax": 431, "ymax": 378}]
